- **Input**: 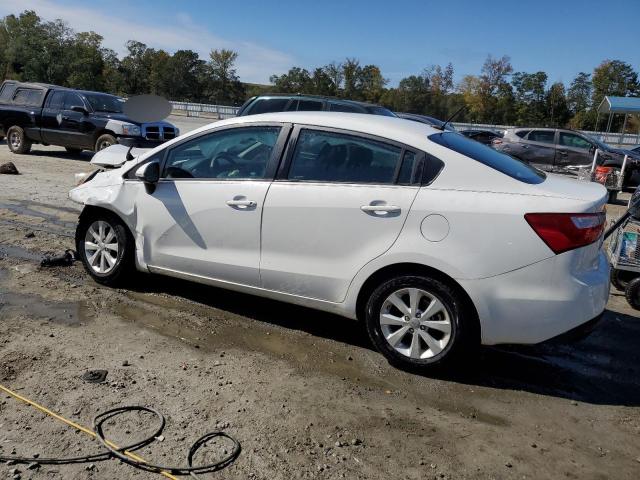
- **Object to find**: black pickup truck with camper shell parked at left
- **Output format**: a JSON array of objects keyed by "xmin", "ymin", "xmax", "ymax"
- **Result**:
[{"xmin": 0, "ymin": 80, "xmax": 179, "ymax": 153}]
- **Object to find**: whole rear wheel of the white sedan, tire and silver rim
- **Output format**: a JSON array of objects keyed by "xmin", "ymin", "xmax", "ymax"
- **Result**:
[{"xmin": 366, "ymin": 275, "xmax": 473, "ymax": 369}]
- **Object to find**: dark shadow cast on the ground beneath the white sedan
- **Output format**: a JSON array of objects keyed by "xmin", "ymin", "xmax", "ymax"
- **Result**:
[{"xmin": 133, "ymin": 275, "xmax": 640, "ymax": 406}]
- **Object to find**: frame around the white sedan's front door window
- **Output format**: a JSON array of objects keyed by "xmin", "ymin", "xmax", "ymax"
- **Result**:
[{"xmin": 122, "ymin": 122, "xmax": 291, "ymax": 183}]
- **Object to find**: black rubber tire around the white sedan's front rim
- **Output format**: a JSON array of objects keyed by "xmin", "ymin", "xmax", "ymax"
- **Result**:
[{"xmin": 76, "ymin": 210, "xmax": 135, "ymax": 287}]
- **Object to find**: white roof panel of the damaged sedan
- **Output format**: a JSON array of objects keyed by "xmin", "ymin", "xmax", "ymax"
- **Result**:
[{"xmin": 199, "ymin": 112, "xmax": 442, "ymax": 148}]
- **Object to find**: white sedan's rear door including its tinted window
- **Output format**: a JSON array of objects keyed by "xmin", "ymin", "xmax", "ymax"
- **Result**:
[{"xmin": 260, "ymin": 126, "xmax": 422, "ymax": 302}]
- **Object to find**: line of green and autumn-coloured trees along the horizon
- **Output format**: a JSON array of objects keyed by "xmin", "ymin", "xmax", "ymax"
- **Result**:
[{"xmin": 0, "ymin": 11, "xmax": 640, "ymax": 132}]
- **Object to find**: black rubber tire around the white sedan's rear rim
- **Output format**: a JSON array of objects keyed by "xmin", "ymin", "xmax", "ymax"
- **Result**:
[{"xmin": 365, "ymin": 275, "xmax": 479, "ymax": 371}]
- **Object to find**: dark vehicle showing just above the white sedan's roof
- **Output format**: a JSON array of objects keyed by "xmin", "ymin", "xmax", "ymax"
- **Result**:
[{"xmin": 238, "ymin": 95, "xmax": 396, "ymax": 117}]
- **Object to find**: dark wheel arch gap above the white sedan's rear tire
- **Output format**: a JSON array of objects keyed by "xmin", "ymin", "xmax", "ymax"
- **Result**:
[{"xmin": 356, "ymin": 262, "xmax": 482, "ymax": 342}]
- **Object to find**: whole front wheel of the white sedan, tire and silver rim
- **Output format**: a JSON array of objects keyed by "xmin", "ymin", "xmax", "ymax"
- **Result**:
[{"xmin": 76, "ymin": 211, "xmax": 134, "ymax": 286}]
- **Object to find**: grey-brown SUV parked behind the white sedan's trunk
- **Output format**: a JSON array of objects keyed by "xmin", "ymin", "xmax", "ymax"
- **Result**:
[{"xmin": 492, "ymin": 128, "xmax": 640, "ymax": 187}]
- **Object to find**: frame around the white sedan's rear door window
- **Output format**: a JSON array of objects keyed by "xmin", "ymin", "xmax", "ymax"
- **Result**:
[{"xmin": 274, "ymin": 124, "xmax": 424, "ymax": 187}]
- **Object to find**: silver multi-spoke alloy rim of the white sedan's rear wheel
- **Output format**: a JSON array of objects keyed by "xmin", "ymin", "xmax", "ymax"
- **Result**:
[{"xmin": 380, "ymin": 288, "xmax": 452, "ymax": 360}]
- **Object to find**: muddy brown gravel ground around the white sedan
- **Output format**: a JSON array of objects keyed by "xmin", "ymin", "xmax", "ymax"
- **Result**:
[{"xmin": 0, "ymin": 124, "xmax": 640, "ymax": 480}]
